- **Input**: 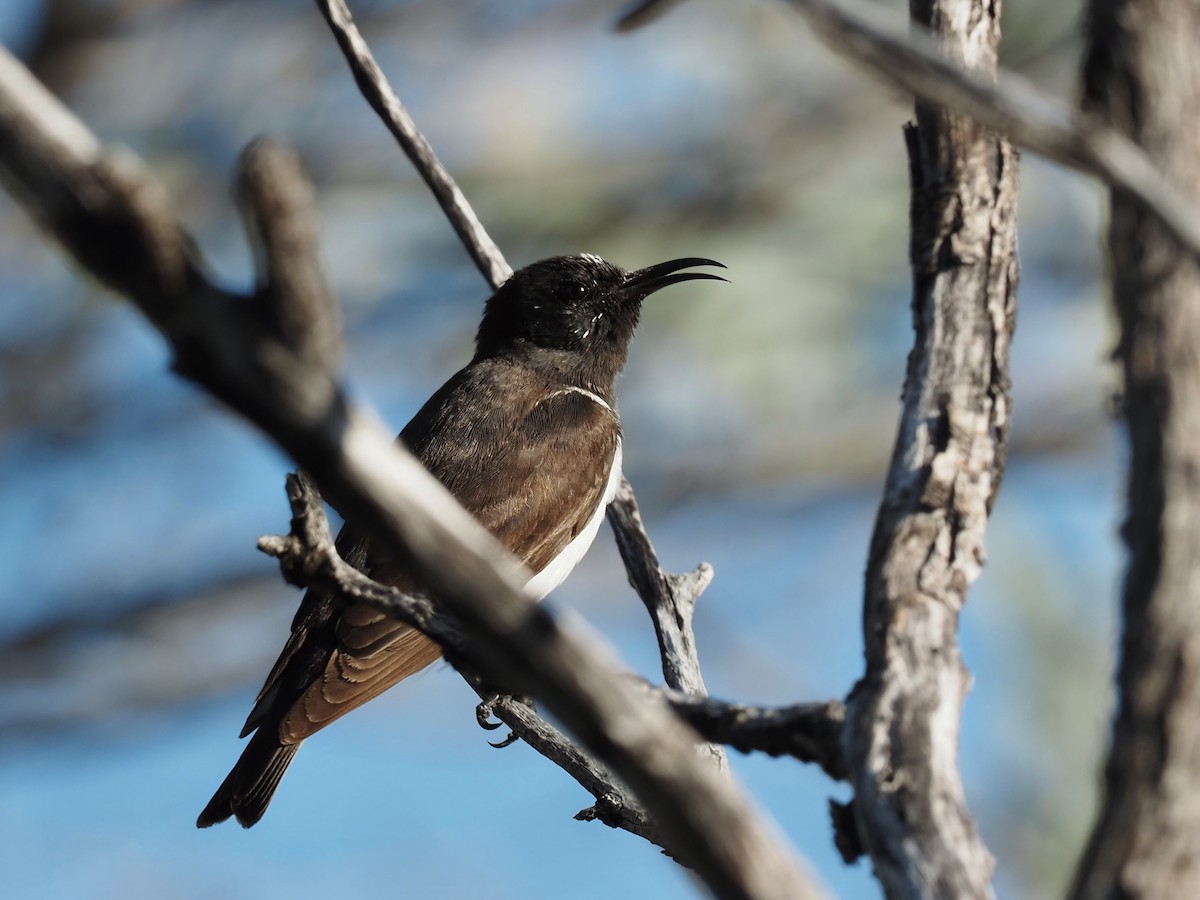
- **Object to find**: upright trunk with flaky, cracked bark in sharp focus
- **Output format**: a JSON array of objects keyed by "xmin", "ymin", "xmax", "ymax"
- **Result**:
[{"xmin": 844, "ymin": 0, "xmax": 1018, "ymax": 898}]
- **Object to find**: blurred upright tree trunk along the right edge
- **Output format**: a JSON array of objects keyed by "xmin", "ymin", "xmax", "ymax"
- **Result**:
[{"xmin": 1073, "ymin": 0, "xmax": 1200, "ymax": 899}]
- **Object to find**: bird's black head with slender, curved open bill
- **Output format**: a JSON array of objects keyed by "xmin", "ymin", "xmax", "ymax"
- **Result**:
[{"xmin": 475, "ymin": 253, "xmax": 725, "ymax": 392}]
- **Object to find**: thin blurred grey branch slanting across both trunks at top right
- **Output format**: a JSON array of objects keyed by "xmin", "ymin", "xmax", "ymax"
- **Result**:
[{"xmin": 617, "ymin": 0, "xmax": 1200, "ymax": 254}]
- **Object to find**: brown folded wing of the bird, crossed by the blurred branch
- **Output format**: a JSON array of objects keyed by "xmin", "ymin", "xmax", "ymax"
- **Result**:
[{"xmin": 247, "ymin": 385, "xmax": 620, "ymax": 745}]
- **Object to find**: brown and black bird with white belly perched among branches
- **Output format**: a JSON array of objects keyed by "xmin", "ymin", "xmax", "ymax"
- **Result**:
[{"xmin": 196, "ymin": 253, "xmax": 727, "ymax": 828}]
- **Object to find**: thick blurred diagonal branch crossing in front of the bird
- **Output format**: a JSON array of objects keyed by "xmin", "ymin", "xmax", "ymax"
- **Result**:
[{"xmin": 0, "ymin": 50, "xmax": 817, "ymax": 900}]
